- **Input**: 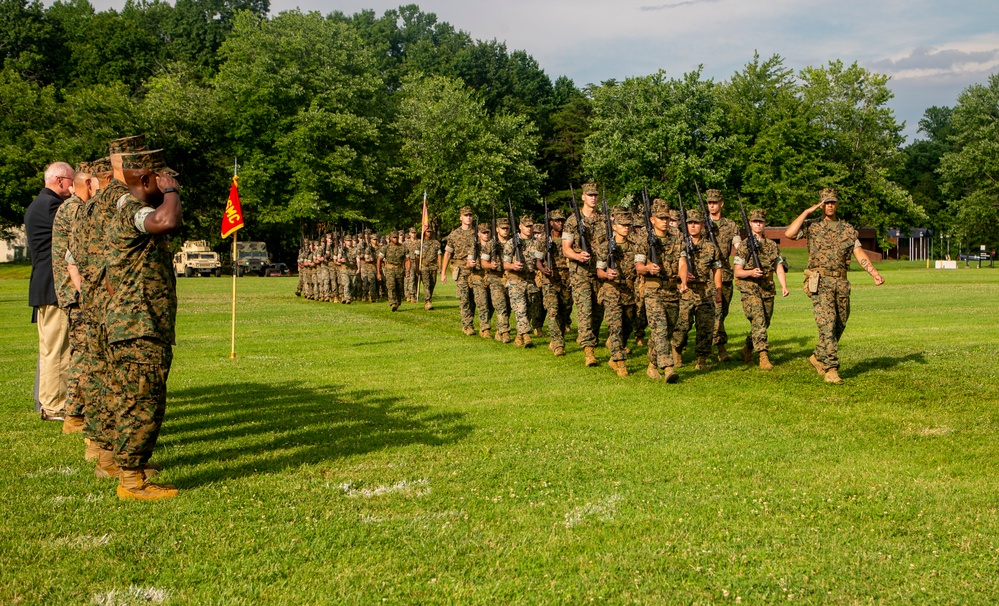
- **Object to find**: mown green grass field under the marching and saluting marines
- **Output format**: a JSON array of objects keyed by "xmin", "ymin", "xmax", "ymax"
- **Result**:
[{"xmin": 0, "ymin": 268, "xmax": 999, "ymax": 604}]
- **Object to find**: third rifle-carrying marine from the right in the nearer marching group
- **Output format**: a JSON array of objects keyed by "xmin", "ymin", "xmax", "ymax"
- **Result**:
[{"xmin": 673, "ymin": 210, "xmax": 722, "ymax": 370}]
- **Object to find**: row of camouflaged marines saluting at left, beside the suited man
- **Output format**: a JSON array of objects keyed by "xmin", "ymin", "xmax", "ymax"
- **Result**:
[{"xmin": 52, "ymin": 135, "xmax": 182, "ymax": 500}]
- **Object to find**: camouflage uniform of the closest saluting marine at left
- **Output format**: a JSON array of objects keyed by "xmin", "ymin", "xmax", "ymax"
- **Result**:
[{"xmin": 105, "ymin": 152, "xmax": 177, "ymax": 468}]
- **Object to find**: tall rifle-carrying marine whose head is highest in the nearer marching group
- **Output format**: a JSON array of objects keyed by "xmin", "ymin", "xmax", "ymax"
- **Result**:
[{"xmin": 562, "ymin": 183, "xmax": 604, "ymax": 366}]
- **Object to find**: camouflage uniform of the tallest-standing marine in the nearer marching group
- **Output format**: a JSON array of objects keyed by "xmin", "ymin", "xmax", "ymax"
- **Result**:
[{"xmin": 562, "ymin": 202, "xmax": 604, "ymax": 347}]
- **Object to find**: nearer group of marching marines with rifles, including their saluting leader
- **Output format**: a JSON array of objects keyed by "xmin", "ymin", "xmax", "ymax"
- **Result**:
[{"xmin": 430, "ymin": 183, "xmax": 884, "ymax": 383}]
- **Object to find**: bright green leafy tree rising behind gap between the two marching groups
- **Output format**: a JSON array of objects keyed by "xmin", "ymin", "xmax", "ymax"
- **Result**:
[{"xmin": 397, "ymin": 76, "xmax": 541, "ymax": 223}]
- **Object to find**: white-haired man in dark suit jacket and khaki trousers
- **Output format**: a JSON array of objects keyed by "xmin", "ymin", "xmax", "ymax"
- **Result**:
[{"xmin": 24, "ymin": 162, "xmax": 76, "ymax": 421}]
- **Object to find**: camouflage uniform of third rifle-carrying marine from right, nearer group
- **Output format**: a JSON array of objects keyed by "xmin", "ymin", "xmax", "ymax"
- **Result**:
[{"xmin": 673, "ymin": 227, "xmax": 722, "ymax": 358}]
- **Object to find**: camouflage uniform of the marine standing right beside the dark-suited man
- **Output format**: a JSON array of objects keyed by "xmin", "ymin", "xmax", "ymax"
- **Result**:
[{"xmin": 52, "ymin": 195, "xmax": 89, "ymax": 417}]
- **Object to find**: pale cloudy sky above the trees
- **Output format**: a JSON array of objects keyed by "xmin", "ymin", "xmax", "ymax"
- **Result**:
[{"xmin": 101, "ymin": 0, "xmax": 999, "ymax": 142}]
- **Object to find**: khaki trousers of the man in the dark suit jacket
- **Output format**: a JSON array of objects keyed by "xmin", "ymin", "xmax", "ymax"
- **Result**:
[{"xmin": 35, "ymin": 305, "xmax": 70, "ymax": 416}]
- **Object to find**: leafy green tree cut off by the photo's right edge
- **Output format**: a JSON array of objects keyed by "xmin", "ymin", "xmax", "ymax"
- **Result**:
[{"xmin": 940, "ymin": 73, "xmax": 999, "ymax": 254}]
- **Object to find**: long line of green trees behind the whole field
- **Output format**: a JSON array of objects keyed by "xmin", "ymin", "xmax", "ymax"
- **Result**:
[{"xmin": 0, "ymin": 0, "xmax": 999, "ymax": 259}]
